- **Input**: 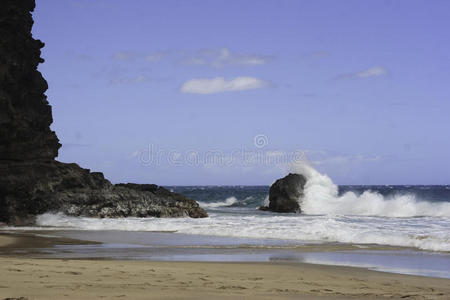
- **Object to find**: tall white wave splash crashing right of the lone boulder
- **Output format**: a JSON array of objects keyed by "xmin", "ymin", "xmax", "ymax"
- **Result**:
[{"xmin": 292, "ymin": 163, "xmax": 450, "ymax": 217}]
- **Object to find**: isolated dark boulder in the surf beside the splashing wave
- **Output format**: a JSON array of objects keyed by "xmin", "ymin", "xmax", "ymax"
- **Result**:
[{"xmin": 260, "ymin": 173, "xmax": 306, "ymax": 213}]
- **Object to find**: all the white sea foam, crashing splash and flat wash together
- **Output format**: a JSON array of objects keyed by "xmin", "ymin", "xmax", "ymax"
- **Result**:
[{"xmin": 11, "ymin": 165, "xmax": 450, "ymax": 251}]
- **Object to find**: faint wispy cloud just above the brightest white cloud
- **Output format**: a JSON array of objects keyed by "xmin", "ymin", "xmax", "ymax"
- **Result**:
[{"xmin": 183, "ymin": 48, "xmax": 271, "ymax": 68}]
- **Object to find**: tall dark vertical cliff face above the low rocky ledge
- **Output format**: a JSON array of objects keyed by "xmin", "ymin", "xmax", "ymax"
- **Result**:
[{"xmin": 0, "ymin": 0, "xmax": 61, "ymax": 160}]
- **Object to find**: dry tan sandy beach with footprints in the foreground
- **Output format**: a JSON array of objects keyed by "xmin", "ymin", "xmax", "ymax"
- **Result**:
[{"xmin": 0, "ymin": 234, "xmax": 450, "ymax": 300}]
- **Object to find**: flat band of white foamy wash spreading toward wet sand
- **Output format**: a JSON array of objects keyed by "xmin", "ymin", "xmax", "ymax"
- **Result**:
[{"xmin": 37, "ymin": 213, "xmax": 450, "ymax": 251}]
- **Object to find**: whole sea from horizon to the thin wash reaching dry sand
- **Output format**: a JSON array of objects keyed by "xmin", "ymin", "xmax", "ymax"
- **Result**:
[{"xmin": 4, "ymin": 167, "xmax": 450, "ymax": 278}]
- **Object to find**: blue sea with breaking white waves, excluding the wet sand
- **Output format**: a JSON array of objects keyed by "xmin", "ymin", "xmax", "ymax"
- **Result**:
[{"xmin": 33, "ymin": 167, "xmax": 450, "ymax": 252}]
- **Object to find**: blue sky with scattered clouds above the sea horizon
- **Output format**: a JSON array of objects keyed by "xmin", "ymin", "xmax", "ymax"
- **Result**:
[{"xmin": 33, "ymin": 0, "xmax": 450, "ymax": 185}]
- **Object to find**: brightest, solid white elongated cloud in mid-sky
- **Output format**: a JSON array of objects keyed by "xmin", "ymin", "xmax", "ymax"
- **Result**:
[{"xmin": 180, "ymin": 77, "xmax": 268, "ymax": 94}]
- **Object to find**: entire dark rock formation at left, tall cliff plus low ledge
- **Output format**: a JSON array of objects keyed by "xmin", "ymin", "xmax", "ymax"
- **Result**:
[{"xmin": 0, "ymin": 0, "xmax": 207, "ymax": 225}]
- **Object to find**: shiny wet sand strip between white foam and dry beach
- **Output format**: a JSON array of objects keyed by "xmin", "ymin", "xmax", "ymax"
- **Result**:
[{"xmin": 0, "ymin": 229, "xmax": 450, "ymax": 279}]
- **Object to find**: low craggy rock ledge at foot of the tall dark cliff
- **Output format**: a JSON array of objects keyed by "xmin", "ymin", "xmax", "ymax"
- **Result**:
[{"xmin": 0, "ymin": 161, "xmax": 206, "ymax": 225}]
